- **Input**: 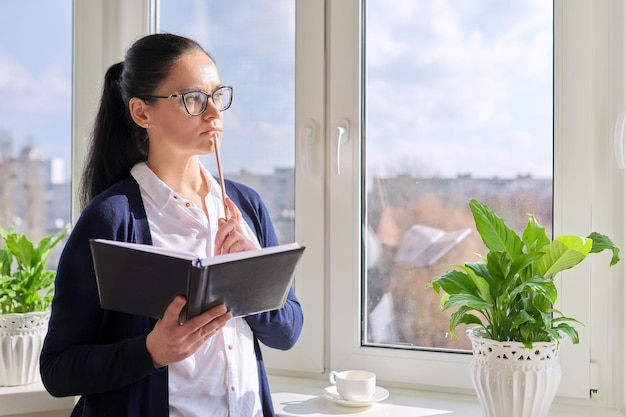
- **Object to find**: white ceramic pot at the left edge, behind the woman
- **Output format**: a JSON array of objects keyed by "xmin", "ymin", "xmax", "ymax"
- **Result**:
[{"xmin": 0, "ymin": 311, "xmax": 50, "ymax": 387}]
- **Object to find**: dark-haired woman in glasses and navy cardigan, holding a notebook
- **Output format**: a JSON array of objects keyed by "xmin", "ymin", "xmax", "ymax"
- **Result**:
[{"xmin": 41, "ymin": 34, "xmax": 303, "ymax": 417}]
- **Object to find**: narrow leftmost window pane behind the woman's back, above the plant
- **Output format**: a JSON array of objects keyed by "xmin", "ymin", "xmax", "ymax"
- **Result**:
[{"xmin": 0, "ymin": 0, "xmax": 72, "ymax": 267}]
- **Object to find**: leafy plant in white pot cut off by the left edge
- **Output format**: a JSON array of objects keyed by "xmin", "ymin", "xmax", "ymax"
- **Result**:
[{"xmin": 0, "ymin": 228, "xmax": 67, "ymax": 386}]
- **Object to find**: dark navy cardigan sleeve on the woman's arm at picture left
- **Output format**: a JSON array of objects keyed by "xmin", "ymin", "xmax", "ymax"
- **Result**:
[{"xmin": 40, "ymin": 183, "xmax": 163, "ymax": 396}]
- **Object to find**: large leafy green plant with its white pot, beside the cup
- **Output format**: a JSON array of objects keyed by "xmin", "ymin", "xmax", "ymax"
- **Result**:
[{"xmin": 427, "ymin": 200, "xmax": 620, "ymax": 417}]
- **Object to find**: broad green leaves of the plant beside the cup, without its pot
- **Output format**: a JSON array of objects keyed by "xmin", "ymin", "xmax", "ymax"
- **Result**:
[{"xmin": 426, "ymin": 200, "xmax": 620, "ymax": 348}]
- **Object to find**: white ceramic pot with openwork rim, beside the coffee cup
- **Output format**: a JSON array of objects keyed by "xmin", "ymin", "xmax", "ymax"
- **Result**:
[{"xmin": 467, "ymin": 327, "xmax": 561, "ymax": 417}]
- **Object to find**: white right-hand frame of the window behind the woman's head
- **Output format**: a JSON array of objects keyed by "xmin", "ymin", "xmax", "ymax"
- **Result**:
[{"xmin": 262, "ymin": 0, "xmax": 328, "ymax": 375}]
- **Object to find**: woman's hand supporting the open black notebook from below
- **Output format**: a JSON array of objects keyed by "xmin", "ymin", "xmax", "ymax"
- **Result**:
[{"xmin": 146, "ymin": 296, "xmax": 232, "ymax": 368}]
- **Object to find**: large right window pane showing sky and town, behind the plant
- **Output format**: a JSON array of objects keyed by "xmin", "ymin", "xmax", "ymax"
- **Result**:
[{"xmin": 363, "ymin": 0, "xmax": 553, "ymax": 350}]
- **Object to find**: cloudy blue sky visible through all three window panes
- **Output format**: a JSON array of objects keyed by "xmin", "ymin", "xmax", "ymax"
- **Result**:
[{"xmin": 0, "ymin": 0, "xmax": 553, "ymax": 178}]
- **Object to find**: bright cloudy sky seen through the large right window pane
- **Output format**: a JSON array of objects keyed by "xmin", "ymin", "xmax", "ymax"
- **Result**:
[{"xmin": 365, "ymin": 0, "xmax": 552, "ymax": 177}]
